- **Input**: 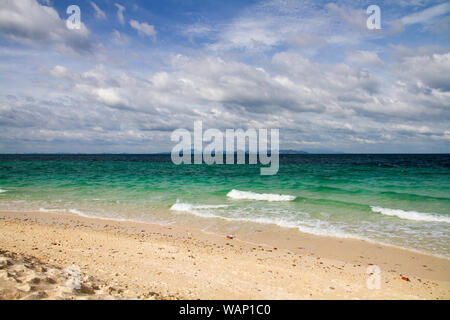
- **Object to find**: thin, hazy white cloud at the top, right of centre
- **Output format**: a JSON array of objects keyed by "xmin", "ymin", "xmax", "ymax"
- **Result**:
[{"xmin": 207, "ymin": 0, "xmax": 382, "ymax": 54}]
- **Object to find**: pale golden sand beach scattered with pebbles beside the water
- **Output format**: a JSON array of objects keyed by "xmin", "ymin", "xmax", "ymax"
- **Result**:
[{"xmin": 0, "ymin": 212, "xmax": 450, "ymax": 300}]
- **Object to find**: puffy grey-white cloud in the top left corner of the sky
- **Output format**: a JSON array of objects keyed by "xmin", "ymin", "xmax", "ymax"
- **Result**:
[{"xmin": 0, "ymin": 0, "xmax": 93, "ymax": 53}]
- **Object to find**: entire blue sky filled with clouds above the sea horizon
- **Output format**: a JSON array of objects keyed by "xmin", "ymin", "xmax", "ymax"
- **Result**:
[{"xmin": 0, "ymin": 0, "xmax": 450, "ymax": 153}]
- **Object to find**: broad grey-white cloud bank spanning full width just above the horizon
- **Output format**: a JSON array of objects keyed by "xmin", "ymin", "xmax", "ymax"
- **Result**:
[{"xmin": 0, "ymin": 44, "xmax": 450, "ymax": 152}]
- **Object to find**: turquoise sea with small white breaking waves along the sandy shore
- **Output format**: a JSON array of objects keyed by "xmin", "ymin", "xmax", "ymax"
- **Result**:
[{"xmin": 0, "ymin": 155, "xmax": 450, "ymax": 257}]
